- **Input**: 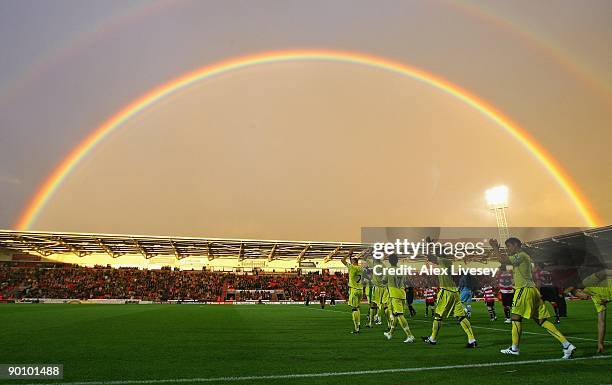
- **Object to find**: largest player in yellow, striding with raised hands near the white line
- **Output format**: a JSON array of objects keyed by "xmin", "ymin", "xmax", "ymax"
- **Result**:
[{"xmin": 489, "ymin": 237, "xmax": 576, "ymax": 359}]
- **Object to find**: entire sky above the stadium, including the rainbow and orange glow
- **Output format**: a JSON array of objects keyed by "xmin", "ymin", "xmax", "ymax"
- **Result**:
[{"xmin": 0, "ymin": 0, "xmax": 612, "ymax": 240}]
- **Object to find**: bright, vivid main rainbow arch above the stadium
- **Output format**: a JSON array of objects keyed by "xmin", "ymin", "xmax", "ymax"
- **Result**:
[{"xmin": 15, "ymin": 49, "xmax": 601, "ymax": 230}]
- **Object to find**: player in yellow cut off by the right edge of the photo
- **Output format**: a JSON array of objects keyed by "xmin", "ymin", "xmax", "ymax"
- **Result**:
[{"xmin": 567, "ymin": 270, "xmax": 612, "ymax": 353}]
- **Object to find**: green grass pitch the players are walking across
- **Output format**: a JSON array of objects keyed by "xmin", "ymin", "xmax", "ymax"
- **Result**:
[{"xmin": 0, "ymin": 301, "xmax": 612, "ymax": 385}]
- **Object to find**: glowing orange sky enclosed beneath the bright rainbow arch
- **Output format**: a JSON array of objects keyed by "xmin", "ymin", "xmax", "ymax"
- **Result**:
[{"xmin": 36, "ymin": 63, "xmax": 596, "ymax": 241}]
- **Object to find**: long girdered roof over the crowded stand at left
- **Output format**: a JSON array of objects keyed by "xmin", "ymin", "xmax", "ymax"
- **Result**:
[{"xmin": 0, "ymin": 230, "xmax": 369, "ymax": 261}]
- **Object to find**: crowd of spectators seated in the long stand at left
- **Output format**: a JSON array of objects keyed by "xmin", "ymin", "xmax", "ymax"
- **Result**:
[{"xmin": 0, "ymin": 265, "xmax": 347, "ymax": 302}]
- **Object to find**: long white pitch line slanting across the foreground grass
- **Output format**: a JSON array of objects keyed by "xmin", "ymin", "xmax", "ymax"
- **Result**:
[{"xmin": 22, "ymin": 356, "xmax": 612, "ymax": 385}]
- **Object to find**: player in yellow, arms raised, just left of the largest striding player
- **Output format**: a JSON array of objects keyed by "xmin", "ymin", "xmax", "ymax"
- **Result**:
[{"xmin": 422, "ymin": 242, "xmax": 478, "ymax": 348}]
